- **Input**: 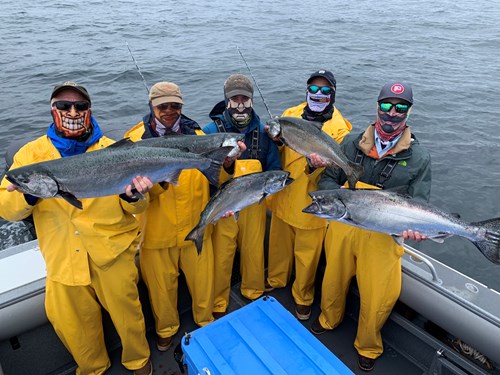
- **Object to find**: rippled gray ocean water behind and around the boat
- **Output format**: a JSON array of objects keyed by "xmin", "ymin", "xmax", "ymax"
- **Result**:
[{"xmin": 0, "ymin": 0, "xmax": 500, "ymax": 290}]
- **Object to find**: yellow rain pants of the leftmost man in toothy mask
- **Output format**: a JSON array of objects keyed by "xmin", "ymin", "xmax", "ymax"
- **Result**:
[{"xmin": 45, "ymin": 244, "xmax": 150, "ymax": 375}]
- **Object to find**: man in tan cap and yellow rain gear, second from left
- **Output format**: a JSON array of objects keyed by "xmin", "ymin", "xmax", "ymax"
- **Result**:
[{"xmin": 125, "ymin": 82, "xmax": 245, "ymax": 352}]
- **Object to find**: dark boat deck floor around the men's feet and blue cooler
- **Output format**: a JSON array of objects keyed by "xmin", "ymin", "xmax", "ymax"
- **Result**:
[{"xmin": 0, "ymin": 250, "xmax": 500, "ymax": 375}]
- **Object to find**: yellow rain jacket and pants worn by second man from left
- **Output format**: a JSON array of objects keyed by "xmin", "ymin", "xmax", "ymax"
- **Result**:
[{"xmin": 125, "ymin": 122, "xmax": 221, "ymax": 332}]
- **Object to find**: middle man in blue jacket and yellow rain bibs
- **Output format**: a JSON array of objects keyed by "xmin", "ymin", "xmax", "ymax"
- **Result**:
[{"xmin": 203, "ymin": 74, "xmax": 281, "ymax": 318}]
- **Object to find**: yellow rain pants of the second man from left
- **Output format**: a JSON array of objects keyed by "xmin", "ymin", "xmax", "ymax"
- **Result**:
[{"xmin": 139, "ymin": 238, "xmax": 214, "ymax": 338}]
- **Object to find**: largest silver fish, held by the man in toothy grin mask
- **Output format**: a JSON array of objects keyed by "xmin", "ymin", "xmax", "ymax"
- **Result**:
[{"xmin": 6, "ymin": 139, "xmax": 233, "ymax": 208}]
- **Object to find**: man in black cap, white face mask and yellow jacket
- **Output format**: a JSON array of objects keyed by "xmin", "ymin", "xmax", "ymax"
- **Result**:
[{"xmin": 266, "ymin": 70, "xmax": 352, "ymax": 320}]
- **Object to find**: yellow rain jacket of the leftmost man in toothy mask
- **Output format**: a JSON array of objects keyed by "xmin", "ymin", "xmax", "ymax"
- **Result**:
[{"xmin": 0, "ymin": 136, "xmax": 147, "ymax": 285}]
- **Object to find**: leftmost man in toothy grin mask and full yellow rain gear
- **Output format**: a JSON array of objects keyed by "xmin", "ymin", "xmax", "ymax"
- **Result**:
[{"xmin": 0, "ymin": 81, "xmax": 153, "ymax": 375}]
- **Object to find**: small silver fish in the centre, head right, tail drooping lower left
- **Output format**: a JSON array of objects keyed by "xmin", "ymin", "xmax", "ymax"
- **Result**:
[{"xmin": 186, "ymin": 171, "xmax": 293, "ymax": 253}]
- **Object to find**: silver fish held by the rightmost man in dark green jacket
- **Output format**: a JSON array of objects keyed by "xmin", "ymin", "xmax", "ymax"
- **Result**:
[{"xmin": 303, "ymin": 189, "xmax": 500, "ymax": 264}]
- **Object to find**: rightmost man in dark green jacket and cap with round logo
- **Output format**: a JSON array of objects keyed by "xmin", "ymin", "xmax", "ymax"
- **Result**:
[{"xmin": 311, "ymin": 81, "xmax": 431, "ymax": 371}]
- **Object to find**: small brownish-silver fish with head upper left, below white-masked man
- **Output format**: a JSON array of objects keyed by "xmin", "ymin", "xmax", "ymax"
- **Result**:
[{"xmin": 267, "ymin": 117, "xmax": 364, "ymax": 189}]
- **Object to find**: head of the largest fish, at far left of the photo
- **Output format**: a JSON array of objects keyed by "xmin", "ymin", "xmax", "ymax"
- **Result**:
[{"xmin": 5, "ymin": 168, "xmax": 59, "ymax": 198}]
